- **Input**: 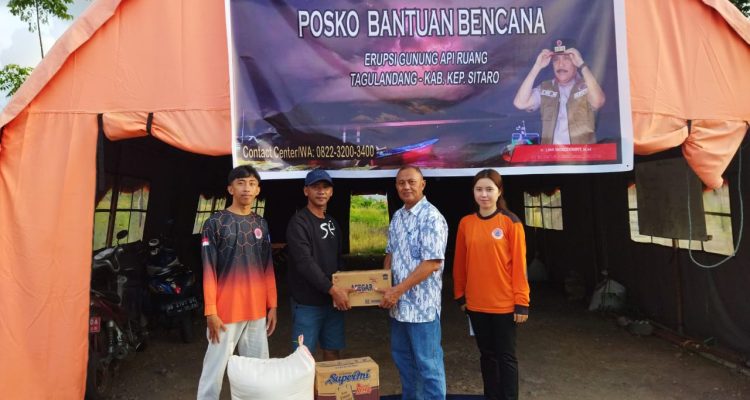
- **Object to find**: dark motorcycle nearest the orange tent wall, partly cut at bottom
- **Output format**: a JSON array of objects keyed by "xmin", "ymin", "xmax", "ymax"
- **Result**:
[{"xmin": 86, "ymin": 230, "xmax": 148, "ymax": 400}]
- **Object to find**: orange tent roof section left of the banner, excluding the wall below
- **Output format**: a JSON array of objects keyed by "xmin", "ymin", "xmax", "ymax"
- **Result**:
[{"xmin": 0, "ymin": 0, "xmax": 231, "ymax": 155}]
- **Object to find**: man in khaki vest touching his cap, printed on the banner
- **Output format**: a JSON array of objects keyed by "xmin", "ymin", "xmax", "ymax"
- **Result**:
[{"xmin": 513, "ymin": 39, "xmax": 605, "ymax": 144}]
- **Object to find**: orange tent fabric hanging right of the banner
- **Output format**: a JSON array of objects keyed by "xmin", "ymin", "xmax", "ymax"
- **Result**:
[{"xmin": 626, "ymin": 0, "xmax": 750, "ymax": 188}]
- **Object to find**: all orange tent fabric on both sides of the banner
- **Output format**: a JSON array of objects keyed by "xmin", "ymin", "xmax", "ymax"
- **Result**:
[{"xmin": 0, "ymin": 0, "xmax": 750, "ymax": 399}]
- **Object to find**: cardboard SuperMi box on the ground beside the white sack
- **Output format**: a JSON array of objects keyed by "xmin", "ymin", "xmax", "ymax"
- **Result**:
[{"xmin": 315, "ymin": 357, "xmax": 380, "ymax": 400}]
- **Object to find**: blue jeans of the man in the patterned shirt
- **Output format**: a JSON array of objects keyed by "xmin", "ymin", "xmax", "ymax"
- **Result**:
[{"xmin": 391, "ymin": 317, "xmax": 445, "ymax": 400}]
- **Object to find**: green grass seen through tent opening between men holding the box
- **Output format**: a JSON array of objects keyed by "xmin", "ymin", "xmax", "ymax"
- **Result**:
[{"xmin": 349, "ymin": 195, "xmax": 388, "ymax": 254}]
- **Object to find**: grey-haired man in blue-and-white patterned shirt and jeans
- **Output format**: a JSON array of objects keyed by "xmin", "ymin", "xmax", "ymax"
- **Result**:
[{"xmin": 380, "ymin": 165, "xmax": 448, "ymax": 400}]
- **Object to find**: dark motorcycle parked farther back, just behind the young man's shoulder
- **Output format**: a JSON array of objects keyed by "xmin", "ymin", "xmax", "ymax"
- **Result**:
[{"xmin": 146, "ymin": 239, "xmax": 200, "ymax": 343}]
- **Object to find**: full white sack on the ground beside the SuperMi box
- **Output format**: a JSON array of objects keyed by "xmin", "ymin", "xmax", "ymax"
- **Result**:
[{"xmin": 227, "ymin": 345, "xmax": 315, "ymax": 400}]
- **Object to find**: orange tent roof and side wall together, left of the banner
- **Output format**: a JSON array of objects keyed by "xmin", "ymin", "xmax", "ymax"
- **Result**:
[{"xmin": 0, "ymin": 0, "xmax": 231, "ymax": 399}]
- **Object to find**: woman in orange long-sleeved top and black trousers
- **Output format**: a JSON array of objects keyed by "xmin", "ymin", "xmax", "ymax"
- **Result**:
[{"xmin": 453, "ymin": 169, "xmax": 529, "ymax": 399}]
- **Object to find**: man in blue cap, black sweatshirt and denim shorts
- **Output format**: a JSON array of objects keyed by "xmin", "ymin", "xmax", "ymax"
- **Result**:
[{"xmin": 286, "ymin": 169, "xmax": 351, "ymax": 361}]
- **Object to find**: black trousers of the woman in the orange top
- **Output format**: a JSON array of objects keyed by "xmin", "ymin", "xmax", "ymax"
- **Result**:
[{"xmin": 468, "ymin": 311, "xmax": 518, "ymax": 400}]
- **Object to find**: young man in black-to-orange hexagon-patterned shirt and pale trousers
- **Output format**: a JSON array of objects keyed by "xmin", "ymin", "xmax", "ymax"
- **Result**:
[{"xmin": 198, "ymin": 165, "xmax": 276, "ymax": 400}]
